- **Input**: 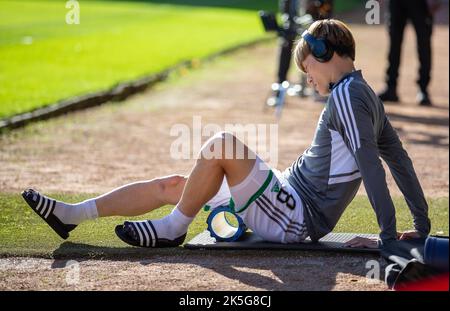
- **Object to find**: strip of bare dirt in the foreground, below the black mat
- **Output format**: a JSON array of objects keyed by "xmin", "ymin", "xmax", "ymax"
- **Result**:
[{"xmin": 0, "ymin": 252, "xmax": 387, "ymax": 291}]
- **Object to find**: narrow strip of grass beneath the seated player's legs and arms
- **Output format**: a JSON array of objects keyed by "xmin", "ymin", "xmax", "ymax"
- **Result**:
[{"xmin": 0, "ymin": 194, "xmax": 449, "ymax": 258}]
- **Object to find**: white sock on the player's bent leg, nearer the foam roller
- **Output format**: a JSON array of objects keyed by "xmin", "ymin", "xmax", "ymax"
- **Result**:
[{"xmin": 152, "ymin": 206, "xmax": 194, "ymax": 240}]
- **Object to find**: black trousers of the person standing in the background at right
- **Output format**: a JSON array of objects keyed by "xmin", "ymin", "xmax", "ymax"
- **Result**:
[{"xmin": 386, "ymin": 0, "xmax": 433, "ymax": 92}]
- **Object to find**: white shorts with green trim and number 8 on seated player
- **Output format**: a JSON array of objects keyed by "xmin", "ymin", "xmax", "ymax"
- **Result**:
[{"xmin": 207, "ymin": 157, "xmax": 308, "ymax": 243}]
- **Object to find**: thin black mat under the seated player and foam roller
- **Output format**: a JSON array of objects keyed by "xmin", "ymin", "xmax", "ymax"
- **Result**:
[{"xmin": 184, "ymin": 230, "xmax": 380, "ymax": 253}]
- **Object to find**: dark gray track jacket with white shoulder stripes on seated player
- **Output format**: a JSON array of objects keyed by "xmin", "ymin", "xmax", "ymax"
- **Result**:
[{"xmin": 284, "ymin": 71, "xmax": 430, "ymax": 241}]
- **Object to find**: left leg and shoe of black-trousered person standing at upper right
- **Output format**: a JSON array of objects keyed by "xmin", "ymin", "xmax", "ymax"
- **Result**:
[{"xmin": 378, "ymin": 0, "xmax": 408, "ymax": 102}]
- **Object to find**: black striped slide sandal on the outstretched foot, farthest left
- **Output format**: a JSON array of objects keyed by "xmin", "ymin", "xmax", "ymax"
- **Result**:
[{"xmin": 22, "ymin": 189, "xmax": 77, "ymax": 240}]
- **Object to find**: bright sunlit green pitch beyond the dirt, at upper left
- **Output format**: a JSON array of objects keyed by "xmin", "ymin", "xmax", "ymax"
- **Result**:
[{"xmin": 0, "ymin": 0, "xmax": 360, "ymax": 119}]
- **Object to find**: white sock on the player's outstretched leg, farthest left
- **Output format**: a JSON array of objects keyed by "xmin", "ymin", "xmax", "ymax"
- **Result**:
[{"xmin": 53, "ymin": 199, "xmax": 98, "ymax": 225}]
